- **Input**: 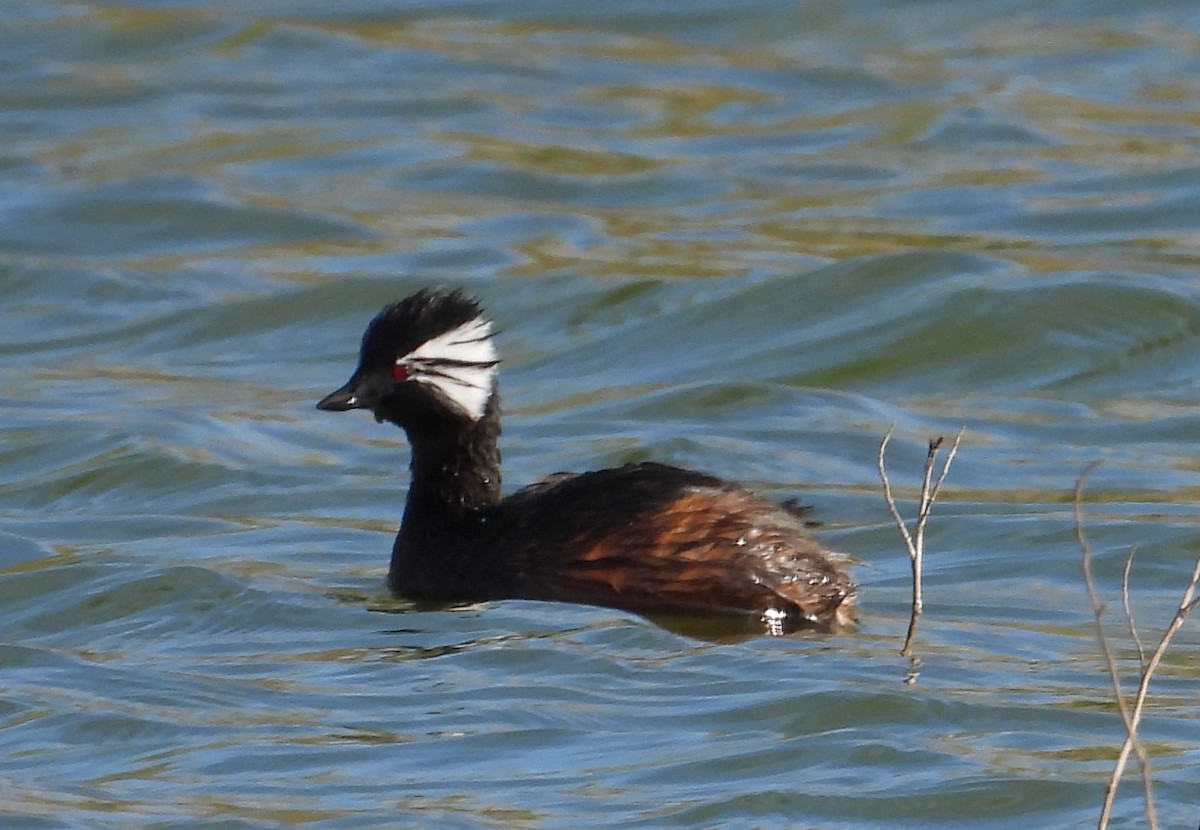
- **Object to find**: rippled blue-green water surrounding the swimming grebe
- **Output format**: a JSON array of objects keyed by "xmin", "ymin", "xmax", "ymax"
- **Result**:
[{"xmin": 0, "ymin": 0, "xmax": 1200, "ymax": 828}]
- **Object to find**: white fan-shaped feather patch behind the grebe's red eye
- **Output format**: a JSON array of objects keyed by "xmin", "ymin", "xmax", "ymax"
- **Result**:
[{"xmin": 396, "ymin": 317, "xmax": 497, "ymax": 421}]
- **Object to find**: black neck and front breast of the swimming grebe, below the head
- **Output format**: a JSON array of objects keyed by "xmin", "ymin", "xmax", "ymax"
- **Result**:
[{"xmin": 389, "ymin": 392, "xmax": 500, "ymax": 590}]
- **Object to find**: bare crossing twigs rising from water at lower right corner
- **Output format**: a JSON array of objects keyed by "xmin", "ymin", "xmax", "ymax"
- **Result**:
[{"xmin": 1075, "ymin": 463, "xmax": 1200, "ymax": 830}]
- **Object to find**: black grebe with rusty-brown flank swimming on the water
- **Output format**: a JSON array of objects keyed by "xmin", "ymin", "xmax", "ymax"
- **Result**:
[{"xmin": 317, "ymin": 288, "xmax": 856, "ymax": 633}]
